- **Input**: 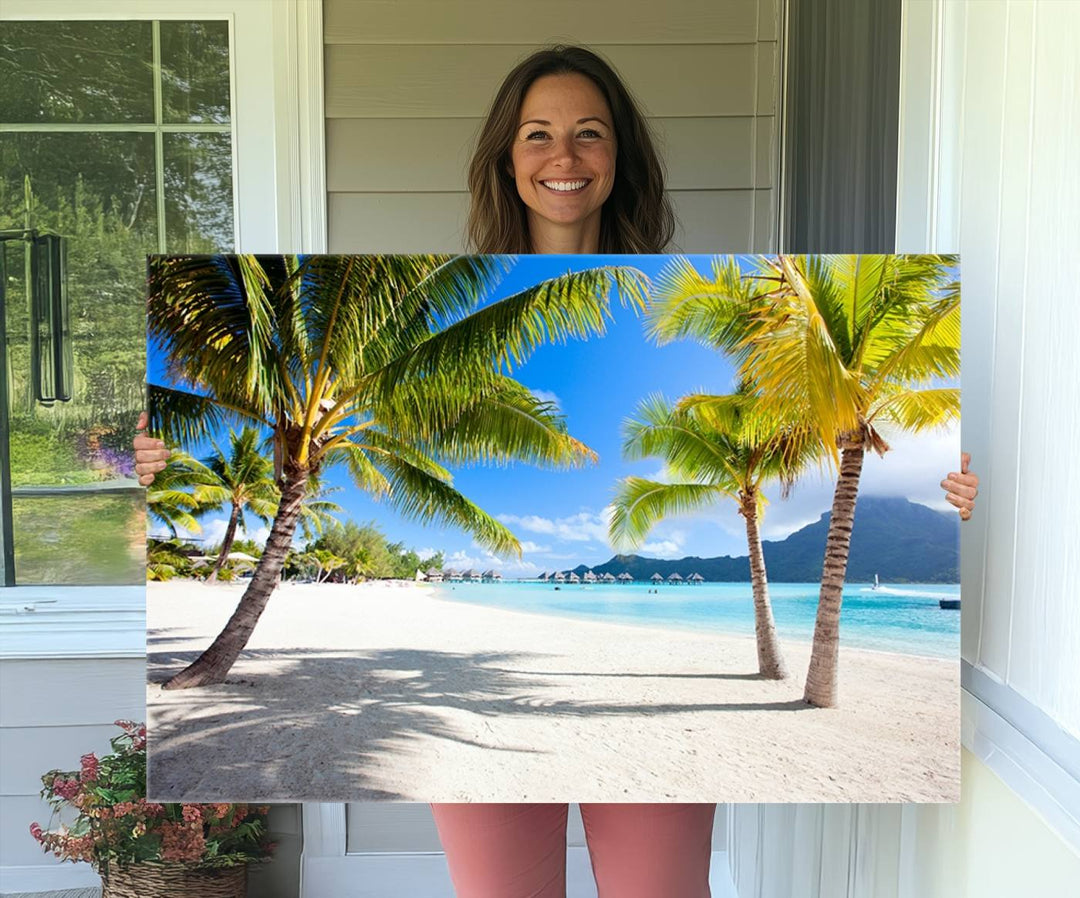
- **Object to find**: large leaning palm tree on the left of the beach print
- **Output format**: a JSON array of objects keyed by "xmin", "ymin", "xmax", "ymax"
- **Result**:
[{"xmin": 148, "ymin": 255, "xmax": 644, "ymax": 688}]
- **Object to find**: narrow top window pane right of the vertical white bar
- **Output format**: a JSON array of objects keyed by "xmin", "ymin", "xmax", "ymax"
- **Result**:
[{"xmin": 161, "ymin": 22, "xmax": 229, "ymax": 123}]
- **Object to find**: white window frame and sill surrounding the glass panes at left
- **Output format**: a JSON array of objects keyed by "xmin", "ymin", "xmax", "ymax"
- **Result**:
[{"xmin": 0, "ymin": 0, "xmax": 326, "ymax": 658}]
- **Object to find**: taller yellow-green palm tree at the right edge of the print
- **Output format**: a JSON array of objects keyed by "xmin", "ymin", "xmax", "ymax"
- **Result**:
[{"xmin": 648, "ymin": 255, "xmax": 960, "ymax": 708}]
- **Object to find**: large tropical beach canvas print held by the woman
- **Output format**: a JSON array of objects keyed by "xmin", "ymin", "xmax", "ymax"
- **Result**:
[{"xmin": 147, "ymin": 255, "xmax": 960, "ymax": 802}]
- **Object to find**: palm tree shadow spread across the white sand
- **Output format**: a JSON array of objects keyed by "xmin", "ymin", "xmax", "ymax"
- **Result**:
[{"xmin": 147, "ymin": 630, "xmax": 813, "ymax": 802}]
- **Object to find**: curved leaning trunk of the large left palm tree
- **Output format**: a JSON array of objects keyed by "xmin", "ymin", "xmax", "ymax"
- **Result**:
[{"xmin": 163, "ymin": 467, "xmax": 308, "ymax": 689}]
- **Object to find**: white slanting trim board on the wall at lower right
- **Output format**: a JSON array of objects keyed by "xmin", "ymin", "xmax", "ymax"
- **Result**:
[{"xmin": 960, "ymin": 678, "xmax": 1080, "ymax": 852}]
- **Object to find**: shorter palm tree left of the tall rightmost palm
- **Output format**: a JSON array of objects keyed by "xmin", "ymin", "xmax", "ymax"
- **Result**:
[{"xmin": 610, "ymin": 387, "xmax": 814, "ymax": 680}]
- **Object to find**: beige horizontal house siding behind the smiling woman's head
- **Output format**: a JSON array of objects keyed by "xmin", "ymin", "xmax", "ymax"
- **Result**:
[{"xmin": 324, "ymin": 0, "xmax": 780, "ymax": 252}]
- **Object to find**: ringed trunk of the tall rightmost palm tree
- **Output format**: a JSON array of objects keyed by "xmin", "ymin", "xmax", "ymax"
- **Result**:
[{"xmin": 802, "ymin": 437, "xmax": 865, "ymax": 708}]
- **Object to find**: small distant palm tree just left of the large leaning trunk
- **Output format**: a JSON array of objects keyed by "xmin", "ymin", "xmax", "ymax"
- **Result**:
[{"xmin": 195, "ymin": 426, "xmax": 281, "ymax": 582}]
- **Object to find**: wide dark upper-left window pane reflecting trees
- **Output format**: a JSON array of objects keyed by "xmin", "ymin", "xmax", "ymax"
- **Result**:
[{"xmin": 0, "ymin": 22, "xmax": 153, "ymax": 123}]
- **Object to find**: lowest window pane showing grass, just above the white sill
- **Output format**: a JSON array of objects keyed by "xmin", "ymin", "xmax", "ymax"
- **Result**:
[{"xmin": 12, "ymin": 494, "xmax": 146, "ymax": 586}]
